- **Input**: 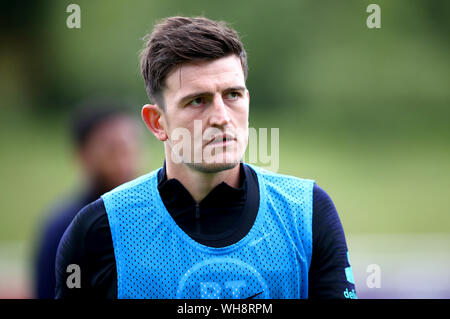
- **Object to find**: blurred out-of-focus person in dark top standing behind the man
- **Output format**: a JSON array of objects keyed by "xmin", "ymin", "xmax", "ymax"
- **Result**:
[{"xmin": 34, "ymin": 100, "xmax": 138, "ymax": 299}]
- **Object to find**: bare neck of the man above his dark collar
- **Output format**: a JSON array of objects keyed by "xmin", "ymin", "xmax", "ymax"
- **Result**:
[{"xmin": 166, "ymin": 160, "xmax": 240, "ymax": 203}]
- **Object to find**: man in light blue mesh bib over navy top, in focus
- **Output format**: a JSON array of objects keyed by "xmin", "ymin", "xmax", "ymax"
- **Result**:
[{"xmin": 57, "ymin": 17, "xmax": 354, "ymax": 298}]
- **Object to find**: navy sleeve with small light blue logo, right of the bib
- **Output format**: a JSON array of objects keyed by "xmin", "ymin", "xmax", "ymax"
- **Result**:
[{"xmin": 308, "ymin": 185, "xmax": 357, "ymax": 299}]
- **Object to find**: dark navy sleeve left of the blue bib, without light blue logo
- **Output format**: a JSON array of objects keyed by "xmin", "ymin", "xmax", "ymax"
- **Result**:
[{"xmin": 55, "ymin": 199, "xmax": 117, "ymax": 299}]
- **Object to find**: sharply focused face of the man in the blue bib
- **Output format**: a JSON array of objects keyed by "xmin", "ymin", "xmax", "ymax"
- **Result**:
[{"xmin": 161, "ymin": 55, "xmax": 249, "ymax": 172}]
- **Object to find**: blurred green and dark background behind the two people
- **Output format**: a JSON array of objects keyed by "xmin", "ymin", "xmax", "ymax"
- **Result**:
[{"xmin": 0, "ymin": 0, "xmax": 450, "ymax": 297}]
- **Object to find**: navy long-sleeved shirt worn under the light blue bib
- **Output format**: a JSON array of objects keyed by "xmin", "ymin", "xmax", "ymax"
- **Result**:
[{"xmin": 56, "ymin": 164, "xmax": 355, "ymax": 299}]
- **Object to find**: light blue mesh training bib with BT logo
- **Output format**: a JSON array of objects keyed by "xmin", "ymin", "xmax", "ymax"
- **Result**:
[{"xmin": 102, "ymin": 164, "xmax": 314, "ymax": 299}]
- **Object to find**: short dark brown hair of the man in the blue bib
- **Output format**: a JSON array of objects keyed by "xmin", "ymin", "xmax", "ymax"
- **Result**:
[{"xmin": 141, "ymin": 16, "xmax": 248, "ymax": 110}]
